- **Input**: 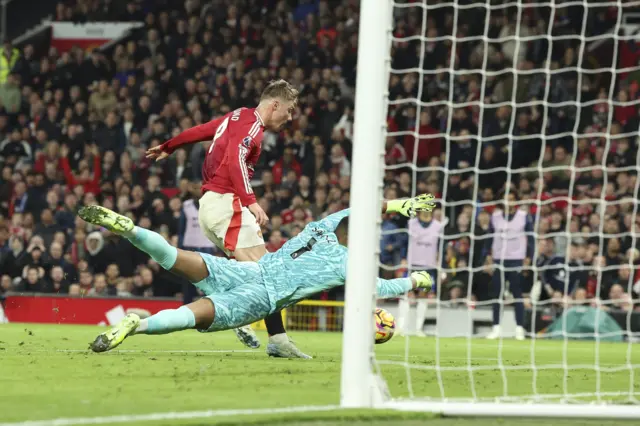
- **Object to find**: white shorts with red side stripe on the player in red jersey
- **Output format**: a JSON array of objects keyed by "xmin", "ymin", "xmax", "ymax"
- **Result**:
[{"xmin": 198, "ymin": 191, "xmax": 264, "ymax": 257}]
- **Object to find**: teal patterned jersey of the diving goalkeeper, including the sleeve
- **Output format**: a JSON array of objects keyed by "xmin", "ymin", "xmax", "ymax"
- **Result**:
[{"xmin": 258, "ymin": 209, "xmax": 411, "ymax": 311}]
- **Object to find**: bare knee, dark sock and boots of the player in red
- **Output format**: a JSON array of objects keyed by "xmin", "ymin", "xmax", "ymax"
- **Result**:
[{"xmin": 233, "ymin": 244, "xmax": 311, "ymax": 359}]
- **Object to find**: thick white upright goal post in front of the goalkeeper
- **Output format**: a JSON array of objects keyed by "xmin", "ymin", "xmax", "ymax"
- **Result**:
[{"xmin": 340, "ymin": 0, "xmax": 392, "ymax": 408}]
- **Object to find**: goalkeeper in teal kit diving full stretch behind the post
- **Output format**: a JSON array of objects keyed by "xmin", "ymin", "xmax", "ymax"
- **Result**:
[{"xmin": 78, "ymin": 195, "xmax": 435, "ymax": 352}]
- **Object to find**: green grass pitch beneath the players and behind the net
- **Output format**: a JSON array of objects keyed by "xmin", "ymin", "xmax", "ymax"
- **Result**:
[{"xmin": 0, "ymin": 324, "xmax": 640, "ymax": 426}]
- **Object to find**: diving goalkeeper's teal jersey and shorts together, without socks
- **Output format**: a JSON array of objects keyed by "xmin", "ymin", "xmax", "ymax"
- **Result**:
[{"xmin": 194, "ymin": 210, "xmax": 412, "ymax": 331}]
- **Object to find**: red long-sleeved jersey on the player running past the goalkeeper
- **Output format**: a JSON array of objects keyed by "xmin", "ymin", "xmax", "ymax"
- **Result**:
[{"xmin": 161, "ymin": 108, "xmax": 264, "ymax": 206}]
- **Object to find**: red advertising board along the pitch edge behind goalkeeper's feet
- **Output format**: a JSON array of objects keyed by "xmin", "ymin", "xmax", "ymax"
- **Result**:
[{"xmin": 0, "ymin": 295, "xmax": 182, "ymax": 325}]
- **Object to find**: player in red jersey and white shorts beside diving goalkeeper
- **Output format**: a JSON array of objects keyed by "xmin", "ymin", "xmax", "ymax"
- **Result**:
[{"xmin": 147, "ymin": 80, "xmax": 310, "ymax": 358}]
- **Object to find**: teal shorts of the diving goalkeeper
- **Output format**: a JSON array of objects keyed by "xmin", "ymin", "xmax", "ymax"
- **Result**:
[{"xmin": 194, "ymin": 253, "xmax": 272, "ymax": 332}]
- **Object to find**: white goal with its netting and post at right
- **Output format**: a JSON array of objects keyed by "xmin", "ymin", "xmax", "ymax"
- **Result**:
[{"xmin": 342, "ymin": 0, "xmax": 640, "ymax": 417}]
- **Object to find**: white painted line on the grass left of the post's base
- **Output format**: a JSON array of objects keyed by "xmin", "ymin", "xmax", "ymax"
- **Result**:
[{"xmin": 0, "ymin": 405, "xmax": 340, "ymax": 426}]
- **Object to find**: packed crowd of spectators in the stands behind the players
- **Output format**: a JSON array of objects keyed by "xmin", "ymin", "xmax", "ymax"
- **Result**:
[{"xmin": 0, "ymin": 0, "xmax": 640, "ymax": 309}]
